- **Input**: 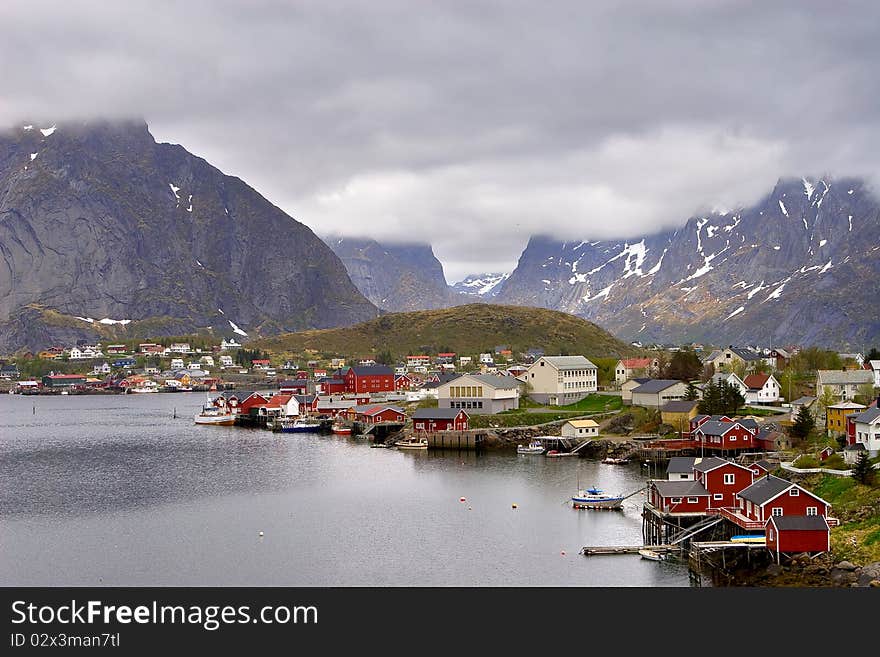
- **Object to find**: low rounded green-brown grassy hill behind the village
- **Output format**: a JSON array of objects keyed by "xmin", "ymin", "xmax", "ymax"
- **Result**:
[{"xmin": 248, "ymin": 303, "xmax": 637, "ymax": 359}]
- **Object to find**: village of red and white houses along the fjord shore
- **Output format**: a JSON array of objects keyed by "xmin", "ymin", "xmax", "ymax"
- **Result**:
[{"xmin": 0, "ymin": 339, "xmax": 880, "ymax": 580}]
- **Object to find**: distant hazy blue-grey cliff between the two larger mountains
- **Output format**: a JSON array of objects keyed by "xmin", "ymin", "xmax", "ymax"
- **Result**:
[{"xmin": 325, "ymin": 237, "xmax": 467, "ymax": 312}]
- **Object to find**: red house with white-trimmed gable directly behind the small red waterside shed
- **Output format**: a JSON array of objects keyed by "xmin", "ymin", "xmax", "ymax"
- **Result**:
[{"xmin": 736, "ymin": 474, "xmax": 836, "ymax": 524}]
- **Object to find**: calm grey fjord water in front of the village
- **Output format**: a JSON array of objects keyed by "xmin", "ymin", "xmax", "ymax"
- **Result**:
[{"xmin": 0, "ymin": 393, "xmax": 689, "ymax": 587}]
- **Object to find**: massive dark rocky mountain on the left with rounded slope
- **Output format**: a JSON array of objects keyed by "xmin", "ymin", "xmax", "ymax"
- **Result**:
[{"xmin": 0, "ymin": 121, "xmax": 378, "ymax": 352}]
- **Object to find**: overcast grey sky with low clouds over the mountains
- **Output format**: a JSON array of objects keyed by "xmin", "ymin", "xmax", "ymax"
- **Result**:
[{"xmin": 0, "ymin": 0, "xmax": 880, "ymax": 283}]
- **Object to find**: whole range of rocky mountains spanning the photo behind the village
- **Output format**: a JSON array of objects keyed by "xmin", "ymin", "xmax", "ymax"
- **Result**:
[{"xmin": 0, "ymin": 120, "xmax": 880, "ymax": 353}]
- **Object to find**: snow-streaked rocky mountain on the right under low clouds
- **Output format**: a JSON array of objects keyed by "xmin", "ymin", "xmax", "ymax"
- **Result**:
[{"xmin": 496, "ymin": 178, "xmax": 880, "ymax": 349}]
